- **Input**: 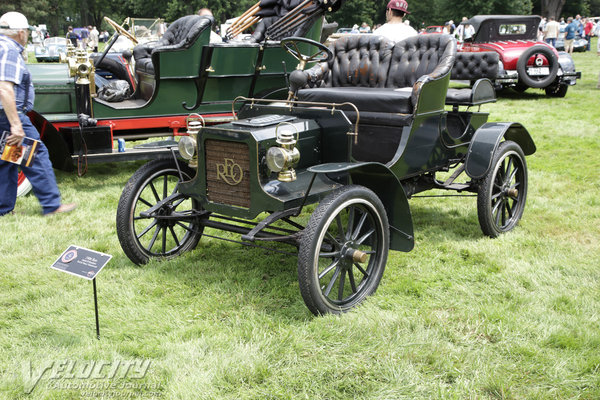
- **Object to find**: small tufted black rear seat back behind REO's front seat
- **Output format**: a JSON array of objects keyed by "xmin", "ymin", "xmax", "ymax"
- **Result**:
[{"xmin": 451, "ymin": 51, "xmax": 500, "ymax": 81}]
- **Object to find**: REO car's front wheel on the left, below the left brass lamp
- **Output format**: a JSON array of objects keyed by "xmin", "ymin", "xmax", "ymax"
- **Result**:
[{"xmin": 117, "ymin": 159, "xmax": 204, "ymax": 265}]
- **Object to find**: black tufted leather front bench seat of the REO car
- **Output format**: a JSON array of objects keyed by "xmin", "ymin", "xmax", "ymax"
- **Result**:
[{"xmin": 298, "ymin": 35, "xmax": 456, "ymax": 114}]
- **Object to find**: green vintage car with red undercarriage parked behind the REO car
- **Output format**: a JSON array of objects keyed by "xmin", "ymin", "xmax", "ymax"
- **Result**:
[{"xmin": 20, "ymin": 0, "xmax": 341, "ymax": 188}]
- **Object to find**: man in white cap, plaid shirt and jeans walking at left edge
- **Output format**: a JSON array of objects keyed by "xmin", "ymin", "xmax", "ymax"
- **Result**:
[{"xmin": 0, "ymin": 11, "xmax": 75, "ymax": 215}]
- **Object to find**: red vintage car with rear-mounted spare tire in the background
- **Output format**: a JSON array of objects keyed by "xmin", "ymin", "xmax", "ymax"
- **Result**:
[{"xmin": 460, "ymin": 15, "xmax": 581, "ymax": 97}]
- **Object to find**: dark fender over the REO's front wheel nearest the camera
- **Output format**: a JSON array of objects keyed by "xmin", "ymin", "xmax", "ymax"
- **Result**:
[{"xmin": 308, "ymin": 162, "xmax": 414, "ymax": 252}]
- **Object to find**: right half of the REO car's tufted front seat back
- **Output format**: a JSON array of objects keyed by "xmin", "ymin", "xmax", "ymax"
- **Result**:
[{"xmin": 385, "ymin": 34, "xmax": 456, "ymax": 88}]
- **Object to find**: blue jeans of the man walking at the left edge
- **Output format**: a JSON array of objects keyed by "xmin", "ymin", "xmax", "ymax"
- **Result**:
[{"xmin": 0, "ymin": 114, "xmax": 60, "ymax": 215}]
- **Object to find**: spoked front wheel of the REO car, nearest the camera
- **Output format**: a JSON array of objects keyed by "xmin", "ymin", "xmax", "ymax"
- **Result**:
[{"xmin": 298, "ymin": 185, "xmax": 390, "ymax": 315}]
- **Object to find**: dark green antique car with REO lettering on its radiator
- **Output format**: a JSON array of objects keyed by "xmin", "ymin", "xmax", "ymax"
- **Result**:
[{"xmin": 116, "ymin": 34, "xmax": 536, "ymax": 314}]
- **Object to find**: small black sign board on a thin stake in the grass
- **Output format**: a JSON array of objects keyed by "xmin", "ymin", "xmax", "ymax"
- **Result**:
[{"xmin": 51, "ymin": 245, "xmax": 112, "ymax": 280}]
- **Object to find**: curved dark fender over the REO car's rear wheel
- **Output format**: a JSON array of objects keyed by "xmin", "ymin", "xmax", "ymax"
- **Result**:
[{"xmin": 465, "ymin": 122, "xmax": 536, "ymax": 179}]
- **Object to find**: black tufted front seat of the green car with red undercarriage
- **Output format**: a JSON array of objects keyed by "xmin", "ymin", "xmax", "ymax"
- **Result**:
[{"xmin": 133, "ymin": 15, "xmax": 214, "ymax": 75}]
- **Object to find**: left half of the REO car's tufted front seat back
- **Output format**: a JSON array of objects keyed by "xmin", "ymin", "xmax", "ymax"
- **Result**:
[{"xmin": 324, "ymin": 35, "xmax": 394, "ymax": 87}]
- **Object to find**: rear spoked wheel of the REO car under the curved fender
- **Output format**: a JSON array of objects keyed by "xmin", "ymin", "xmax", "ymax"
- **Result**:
[{"xmin": 477, "ymin": 140, "xmax": 527, "ymax": 238}]
